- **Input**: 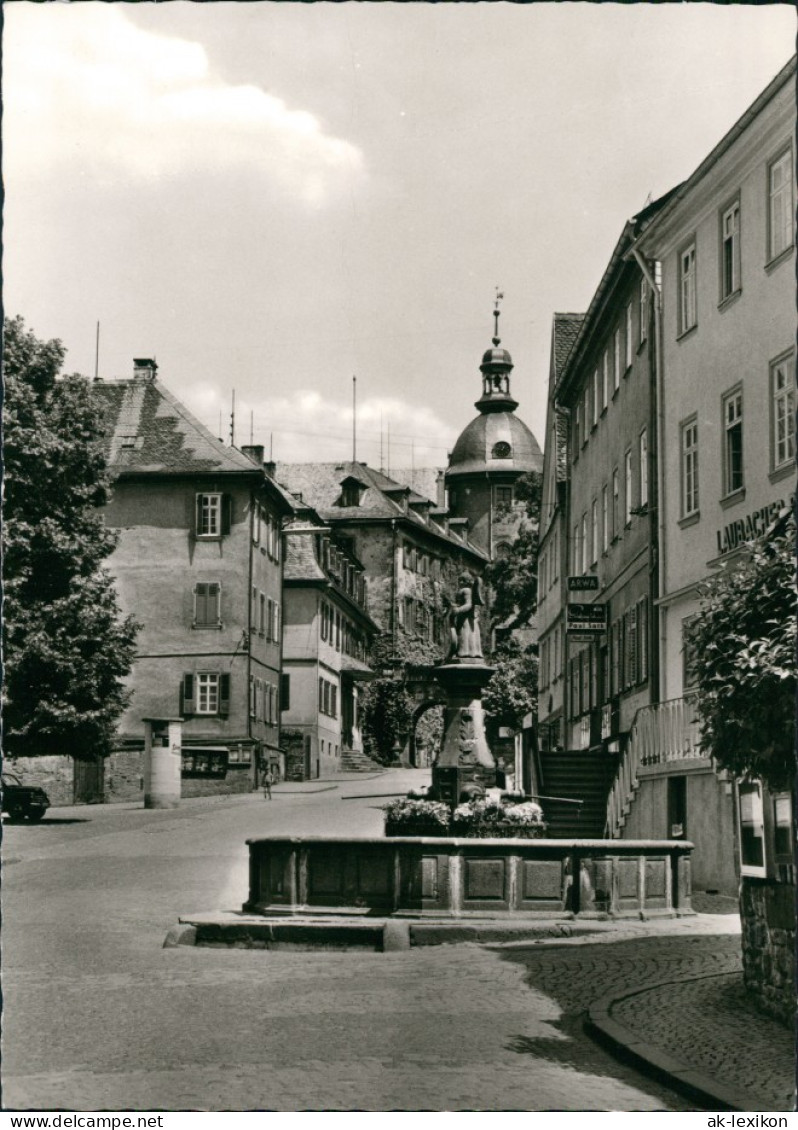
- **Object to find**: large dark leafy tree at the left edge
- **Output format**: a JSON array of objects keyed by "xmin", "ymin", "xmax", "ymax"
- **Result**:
[{"xmin": 2, "ymin": 318, "xmax": 136, "ymax": 758}]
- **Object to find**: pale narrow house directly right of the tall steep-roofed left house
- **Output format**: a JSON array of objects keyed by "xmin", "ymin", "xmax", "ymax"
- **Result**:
[{"xmin": 281, "ymin": 503, "xmax": 378, "ymax": 780}]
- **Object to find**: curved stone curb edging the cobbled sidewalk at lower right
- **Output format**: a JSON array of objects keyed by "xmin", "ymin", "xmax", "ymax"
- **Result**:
[{"xmin": 584, "ymin": 973, "xmax": 762, "ymax": 1112}]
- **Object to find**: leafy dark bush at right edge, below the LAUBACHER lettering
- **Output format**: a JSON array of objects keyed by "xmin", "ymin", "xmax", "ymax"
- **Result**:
[{"xmin": 688, "ymin": 514, "xmax": 796, "ymax": 789}]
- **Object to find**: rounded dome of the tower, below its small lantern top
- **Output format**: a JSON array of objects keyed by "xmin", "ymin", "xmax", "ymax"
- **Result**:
[{"xmin": 446, "ymin": 411, "xmax": 543, "ymax": 478}]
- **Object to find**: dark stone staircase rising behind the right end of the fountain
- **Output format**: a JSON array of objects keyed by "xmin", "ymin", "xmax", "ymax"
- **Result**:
[{"xmin": 539, "ymin": 749, "xmax": 615, "ymax": 840}]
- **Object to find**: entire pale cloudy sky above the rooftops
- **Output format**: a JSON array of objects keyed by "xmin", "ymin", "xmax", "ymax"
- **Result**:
[{"xmin": 2, "ymin": 0, "xmax": 796, "ymax": 477}]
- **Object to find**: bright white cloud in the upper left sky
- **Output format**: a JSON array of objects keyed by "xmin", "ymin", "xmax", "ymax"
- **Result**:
[{"xmin": 3, "ymin": 3, "xmax": 363, "ymax": 206}]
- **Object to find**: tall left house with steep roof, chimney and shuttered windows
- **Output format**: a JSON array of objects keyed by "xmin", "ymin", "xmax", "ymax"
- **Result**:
[{"xmin": 90, "ymin": 359, "xmax": 292, "ymax": 800}]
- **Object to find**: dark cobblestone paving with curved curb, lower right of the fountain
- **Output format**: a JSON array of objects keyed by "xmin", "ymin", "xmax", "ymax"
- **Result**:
[{"xmin": 495, "ymin": 922, "xmax": 796, "ymax": 1111}]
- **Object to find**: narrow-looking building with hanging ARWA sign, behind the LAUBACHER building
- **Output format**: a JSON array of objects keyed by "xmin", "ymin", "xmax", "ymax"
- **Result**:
[{"xmin": 547, "ymin": 201, "xmax": 662, "ymax": 754}]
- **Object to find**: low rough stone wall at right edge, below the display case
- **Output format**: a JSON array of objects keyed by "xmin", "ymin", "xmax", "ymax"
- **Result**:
[{"xmin": 740, "ymin": 877, "xmax": 796, "ymax": 1026}]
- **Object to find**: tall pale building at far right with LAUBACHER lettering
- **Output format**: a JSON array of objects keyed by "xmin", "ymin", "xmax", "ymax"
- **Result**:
[{"xmin": 624, "ymin": 59, "xmax": 796, "ymax": 889}]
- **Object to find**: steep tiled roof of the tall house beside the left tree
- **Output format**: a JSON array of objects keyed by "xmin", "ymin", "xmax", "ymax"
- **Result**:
[{"xmin": 92, "ymin": 377, "xmax": 259, "ymax": 476}]
